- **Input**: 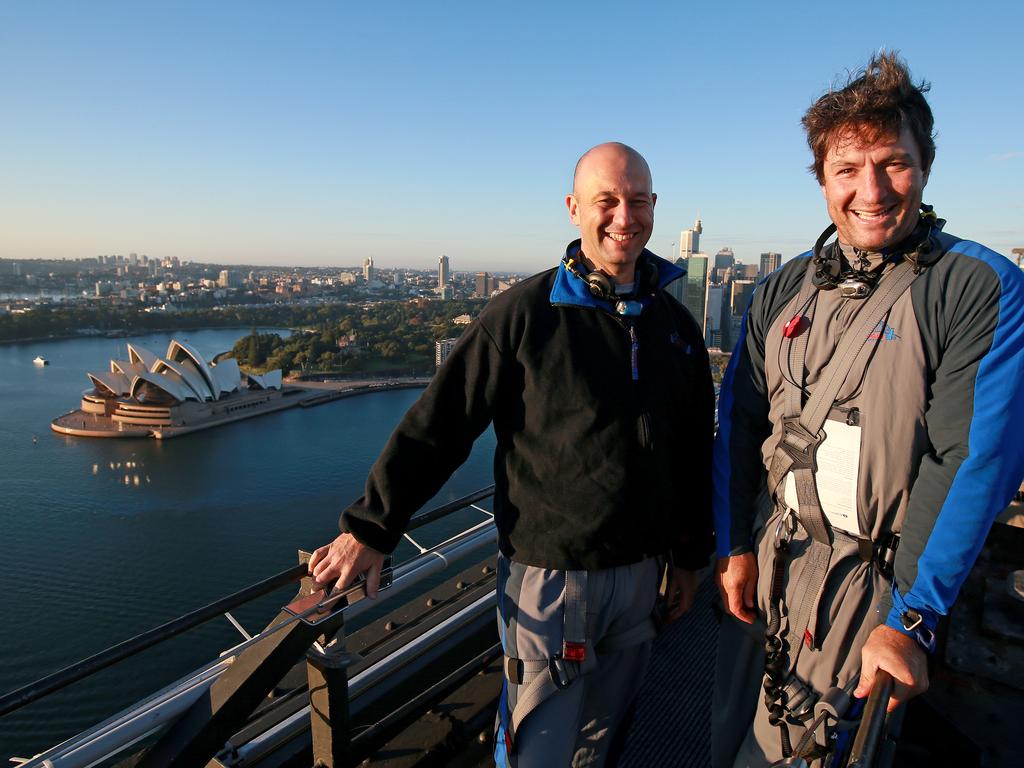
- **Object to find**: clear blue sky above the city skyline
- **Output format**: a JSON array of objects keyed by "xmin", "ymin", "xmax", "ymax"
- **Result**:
[{"xmin": 0, "ymin": 0, "xmax": 1024, "ymax": 271}]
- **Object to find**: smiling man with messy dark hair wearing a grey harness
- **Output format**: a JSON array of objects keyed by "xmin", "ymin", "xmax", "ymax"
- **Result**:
[{"xmin": 713, "ymin": 52, "xmax": 1024, "ymax": 768}]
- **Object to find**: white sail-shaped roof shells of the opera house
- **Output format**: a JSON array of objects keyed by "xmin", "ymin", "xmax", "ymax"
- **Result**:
[{"xmin": 88, "ymin": 339, "xmax": 282, "ymax": 402}]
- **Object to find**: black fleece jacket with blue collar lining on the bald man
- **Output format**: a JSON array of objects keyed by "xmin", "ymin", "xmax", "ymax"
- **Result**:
[{"xmin": 341, "ymin": 242, "xmax": 714, "ymax": 569}]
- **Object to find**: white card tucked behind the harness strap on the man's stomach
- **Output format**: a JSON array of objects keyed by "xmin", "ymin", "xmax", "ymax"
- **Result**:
[{"xmin": 785, "ymin": 420, "xmax": 863, "ymax": 536}]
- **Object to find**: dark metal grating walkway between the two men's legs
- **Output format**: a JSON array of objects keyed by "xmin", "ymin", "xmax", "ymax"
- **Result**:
[{"xmin": 620, "ymin": 573, "xmax": 718, "ymax": 768}]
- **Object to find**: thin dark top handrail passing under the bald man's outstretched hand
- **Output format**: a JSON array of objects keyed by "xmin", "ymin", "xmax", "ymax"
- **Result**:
[{"xmin": 0, "ymin": 485, "xmax": 495, "ymax": 717}]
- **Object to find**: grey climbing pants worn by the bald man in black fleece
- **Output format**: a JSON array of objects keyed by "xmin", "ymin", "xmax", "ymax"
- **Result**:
[{"xmin": 495, "ymin": 556, "xmax": 662, "ymax": 768}]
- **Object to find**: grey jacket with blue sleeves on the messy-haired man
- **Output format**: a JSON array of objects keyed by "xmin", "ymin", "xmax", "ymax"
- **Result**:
[{"xmin": 714, "ymin": 225, "xmax": 1024, "ymax": 631}]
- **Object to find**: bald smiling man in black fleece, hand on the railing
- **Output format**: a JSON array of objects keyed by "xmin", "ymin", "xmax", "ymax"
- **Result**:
[{"xmin": 310, "ymin": 143, "xmax": 715, "ymax": 768}]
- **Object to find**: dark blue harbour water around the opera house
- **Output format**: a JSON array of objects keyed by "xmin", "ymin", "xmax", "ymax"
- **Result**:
[{"xmin": 0, "ymin": 329, "xmax": 495, "ymax": 760}]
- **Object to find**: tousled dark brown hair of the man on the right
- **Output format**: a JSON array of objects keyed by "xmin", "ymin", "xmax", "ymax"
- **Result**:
[{"xmin": 801, "ymin": 51, "xmax": 935, "ymax": 183}]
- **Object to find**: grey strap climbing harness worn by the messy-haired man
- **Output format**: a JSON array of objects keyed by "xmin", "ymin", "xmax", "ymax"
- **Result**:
[{"xmin": 763, "ymin": 207, "xmax": 944, "ymax": 766}]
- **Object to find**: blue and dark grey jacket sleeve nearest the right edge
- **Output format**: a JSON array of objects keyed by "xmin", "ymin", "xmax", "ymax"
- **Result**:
[{"xmin": 882, "ymin": 242, "xmax": 1024, "ymax": 632}]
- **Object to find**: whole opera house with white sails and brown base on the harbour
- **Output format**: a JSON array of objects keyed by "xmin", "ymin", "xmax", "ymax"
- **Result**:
[{"xmin": 50, "ymin": 340, "xmax": 294, "ymax": 438}]
